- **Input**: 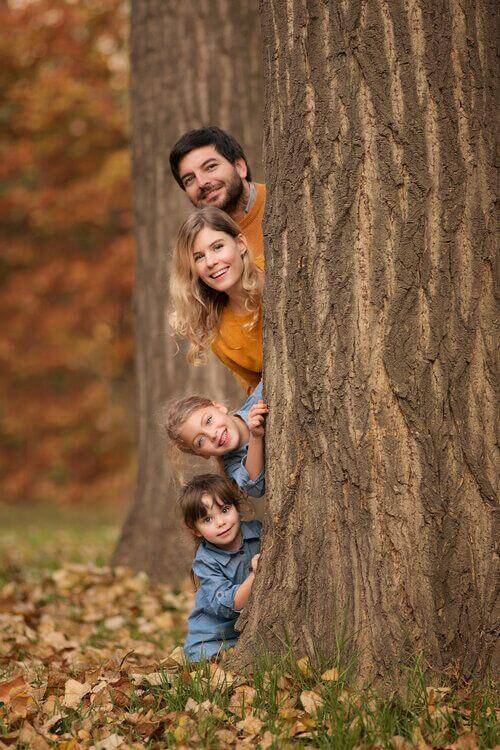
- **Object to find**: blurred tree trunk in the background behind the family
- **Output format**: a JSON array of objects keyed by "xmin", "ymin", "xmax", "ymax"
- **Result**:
[{"xmin": 115, "ymin": 0, "xmax": 261, "ymax": 582}]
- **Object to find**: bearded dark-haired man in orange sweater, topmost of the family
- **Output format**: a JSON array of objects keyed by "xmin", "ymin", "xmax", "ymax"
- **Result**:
[{"xmin": 170, "ymin": 125, "xmax": 266, "ymax": 258}]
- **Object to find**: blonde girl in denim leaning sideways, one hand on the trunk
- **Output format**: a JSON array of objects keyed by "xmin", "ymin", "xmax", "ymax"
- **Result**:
[{"xmin": 160, "ymin": 381, "xmax": 269, "ymax": 497}]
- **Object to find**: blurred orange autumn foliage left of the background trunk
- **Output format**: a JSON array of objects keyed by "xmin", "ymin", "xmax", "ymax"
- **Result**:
[{"xmin": 0, "ymin": 0, "xmax": 134, "ymax": 503}]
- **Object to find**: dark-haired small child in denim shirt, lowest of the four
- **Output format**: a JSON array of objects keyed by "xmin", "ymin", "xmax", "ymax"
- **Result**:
[{"xmin": 180, "ymin": 474, "xmax": 261, "ymax": 661}]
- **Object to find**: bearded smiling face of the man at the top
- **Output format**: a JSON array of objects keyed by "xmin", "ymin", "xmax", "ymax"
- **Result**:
[{"xmin": 179, "ymin": 146, "xmax": 247, "ymax": 214}]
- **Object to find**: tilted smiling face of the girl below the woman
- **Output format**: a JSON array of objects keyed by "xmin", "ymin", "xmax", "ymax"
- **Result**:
[{"xmin": 179, "ymin": 401, "xmax": 248, "ymax": 458}]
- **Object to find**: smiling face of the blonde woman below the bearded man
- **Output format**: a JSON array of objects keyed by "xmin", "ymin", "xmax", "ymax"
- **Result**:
[{"xmin": 193, "ymin": 227, "xmax": 247, "ymax": 295}]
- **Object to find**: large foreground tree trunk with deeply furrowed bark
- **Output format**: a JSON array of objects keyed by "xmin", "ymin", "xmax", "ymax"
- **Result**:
[{"xmin": 236, "ymin": 0, "xmax": 497, "ymax": 679}]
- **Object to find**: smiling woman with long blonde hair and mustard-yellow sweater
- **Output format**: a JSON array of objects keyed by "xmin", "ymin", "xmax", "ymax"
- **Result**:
[{"xmin": 169, "ymin": 206, "xmax": 264, "ymax": 393}]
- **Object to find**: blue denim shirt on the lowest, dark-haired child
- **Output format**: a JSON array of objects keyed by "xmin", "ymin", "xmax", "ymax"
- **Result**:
[{"xmin": 184, "ymin": 521, "xmax": 262, "ymax": 661}]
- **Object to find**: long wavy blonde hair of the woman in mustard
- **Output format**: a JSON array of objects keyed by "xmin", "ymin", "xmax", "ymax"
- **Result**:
[{"xmin": 168, "ymin": 206, "xmax": 261, "ymax": 365}]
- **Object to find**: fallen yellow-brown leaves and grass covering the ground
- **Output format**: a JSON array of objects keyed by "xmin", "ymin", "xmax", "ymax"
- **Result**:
[{"xmin": 0, "ymin": 563, "xmax": 498, "ymax": 750}]
